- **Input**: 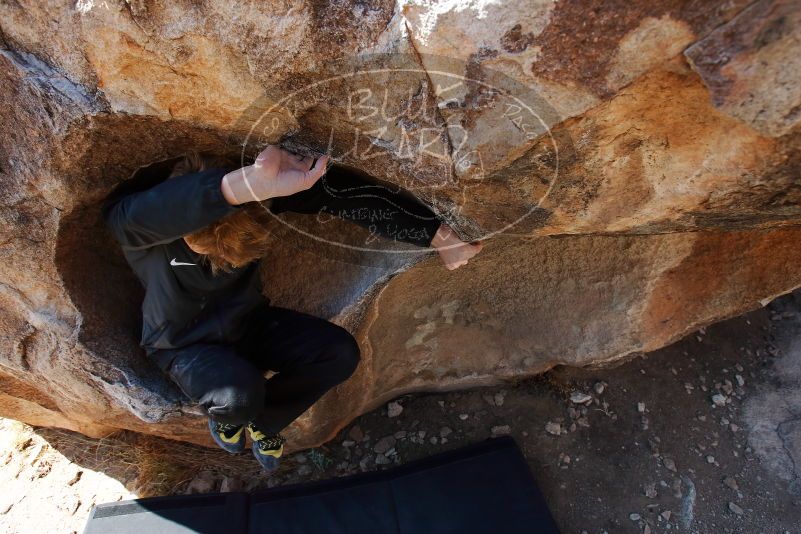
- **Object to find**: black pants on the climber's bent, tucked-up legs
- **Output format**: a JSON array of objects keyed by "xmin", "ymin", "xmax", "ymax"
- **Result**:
[{"xmin": 154, "ymin": 302, "xmax": 360, "ymax": 434}]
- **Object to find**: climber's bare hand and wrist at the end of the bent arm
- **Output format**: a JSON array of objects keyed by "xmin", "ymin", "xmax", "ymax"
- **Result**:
[{"xmin": 221, "ymin": 145, "xmax": 331, "ymax": 204}]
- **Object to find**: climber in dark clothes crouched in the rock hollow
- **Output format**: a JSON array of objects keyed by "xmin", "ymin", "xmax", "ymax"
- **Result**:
[{"xmin": 102, "ymin": 145, "xmax": 482, "ymax": 471}]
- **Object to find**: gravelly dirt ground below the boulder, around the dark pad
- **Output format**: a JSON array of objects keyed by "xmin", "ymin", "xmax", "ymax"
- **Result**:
[{"xmin": 0, "ymin": 291, "xmax": 801, "ymax": 534}]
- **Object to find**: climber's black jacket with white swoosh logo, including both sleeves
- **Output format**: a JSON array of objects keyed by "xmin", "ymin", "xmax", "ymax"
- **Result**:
[{"xmin": 102, "ymin": 164, "xmax": 440, "ymax": 356}]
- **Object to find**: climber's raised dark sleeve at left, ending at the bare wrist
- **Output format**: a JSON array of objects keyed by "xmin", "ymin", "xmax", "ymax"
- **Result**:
[{"xmin": 102, "ymin": 169, "xmax": 241, "ymax": 249}]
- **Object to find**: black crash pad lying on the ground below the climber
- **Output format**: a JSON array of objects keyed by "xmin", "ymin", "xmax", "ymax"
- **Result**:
[{"xmin": 84, "ymin": 436, "xmax": 558, "ymax": 534}]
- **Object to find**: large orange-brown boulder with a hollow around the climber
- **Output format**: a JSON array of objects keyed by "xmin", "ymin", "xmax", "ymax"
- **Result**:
[{"xmin": 0, "ymin": 0, "xmax": 801, "ymax": 449}]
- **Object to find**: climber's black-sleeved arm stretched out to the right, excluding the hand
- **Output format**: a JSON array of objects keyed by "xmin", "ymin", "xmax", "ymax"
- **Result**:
[{"xmin": 270, "ymin": 169, "xmax": 441, "ymax": 247}]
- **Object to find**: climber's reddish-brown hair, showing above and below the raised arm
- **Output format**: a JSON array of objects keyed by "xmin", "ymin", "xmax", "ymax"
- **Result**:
[{"xmin": 168, "ymin": 152, "xmax": 269, "ymax": 275}]
